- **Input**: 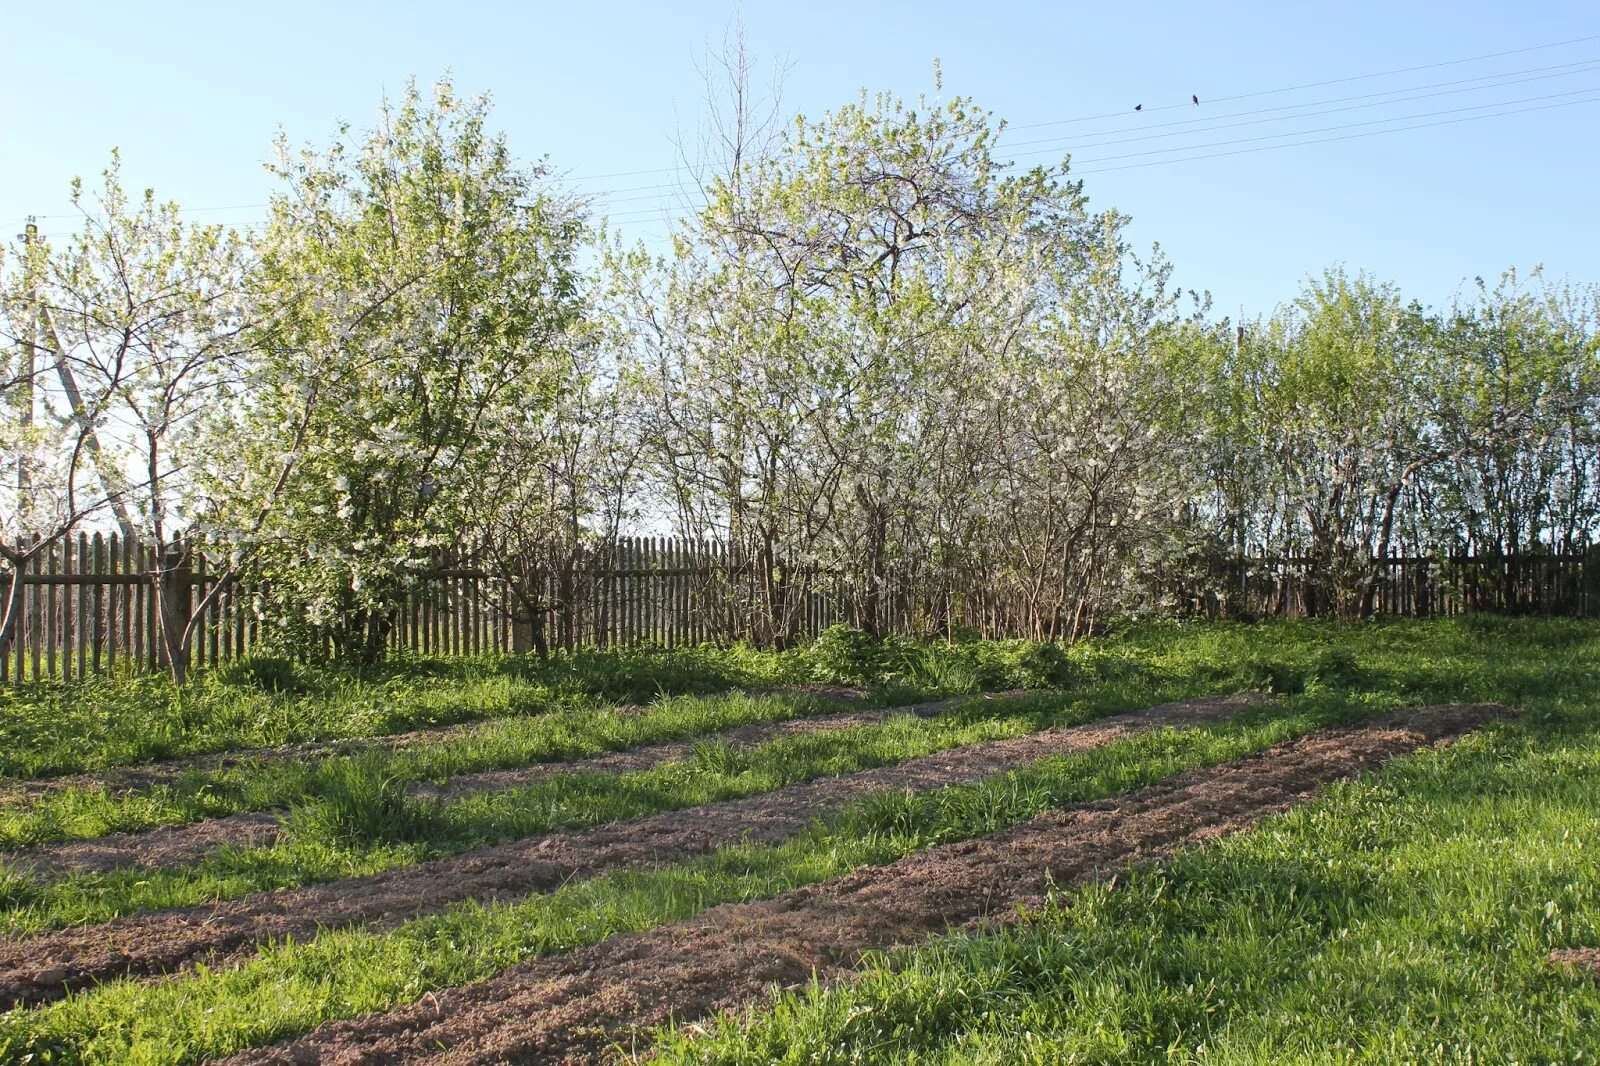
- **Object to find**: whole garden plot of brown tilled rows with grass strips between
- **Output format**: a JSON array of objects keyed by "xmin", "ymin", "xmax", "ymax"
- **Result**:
[{"xmin": 0, "ymin": 617, "xmax": 1589, "ymax": 1063}]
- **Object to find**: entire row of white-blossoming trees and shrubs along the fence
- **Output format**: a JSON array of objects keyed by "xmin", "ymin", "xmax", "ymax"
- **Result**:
[{"xmin": 0, "ymin": 80, "xmax": 1600, "ymax": 671}]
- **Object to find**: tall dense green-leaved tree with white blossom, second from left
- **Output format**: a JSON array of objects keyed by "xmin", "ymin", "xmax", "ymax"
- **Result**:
[{"xmin": 238, "ymin": 82, "xmax": 582, "ymax": 663}]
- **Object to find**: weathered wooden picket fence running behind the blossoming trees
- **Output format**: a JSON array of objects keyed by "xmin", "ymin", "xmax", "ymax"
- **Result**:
[{"xmin": 0, "ymin": 533, "xmax": 1600, "ymax": 680}]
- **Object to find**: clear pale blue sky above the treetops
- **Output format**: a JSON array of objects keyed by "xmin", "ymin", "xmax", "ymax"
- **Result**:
[{"xmin": 0, "ymin": 0, "xmax": 1600, "ymax": 315}]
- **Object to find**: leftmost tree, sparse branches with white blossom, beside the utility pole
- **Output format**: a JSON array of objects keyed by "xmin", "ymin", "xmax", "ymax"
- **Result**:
[{"xmin": 0, "ymin": 154, "xmax": 261, "ymax": 680}]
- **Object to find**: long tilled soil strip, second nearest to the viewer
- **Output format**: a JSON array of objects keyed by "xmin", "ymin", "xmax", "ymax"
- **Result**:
[{"xmin": 0, "ymin": 693, "xmax": 1266, "ymax": 1007}]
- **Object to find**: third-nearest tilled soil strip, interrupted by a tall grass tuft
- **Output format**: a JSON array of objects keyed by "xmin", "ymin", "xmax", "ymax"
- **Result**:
[{"xmin": 0, "ymin": 691, "xmax": 998, "ymax": 880}]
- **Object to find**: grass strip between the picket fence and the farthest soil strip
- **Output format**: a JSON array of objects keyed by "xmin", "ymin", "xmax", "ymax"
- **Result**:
[{"xmin": 0, "ymin": 631, "xmax": 1270, "ymax": 779}]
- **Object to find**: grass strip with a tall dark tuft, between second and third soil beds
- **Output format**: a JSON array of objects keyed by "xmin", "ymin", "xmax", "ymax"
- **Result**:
[{"xmin": 0, "ymin": 687, "xmax": 1196, "ymax": 935}]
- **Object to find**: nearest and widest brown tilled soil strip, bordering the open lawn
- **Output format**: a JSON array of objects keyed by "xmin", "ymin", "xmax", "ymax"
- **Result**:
[{"xmin": 227, "ymin": 706, "xmax": 1507, "ymax": 1066}]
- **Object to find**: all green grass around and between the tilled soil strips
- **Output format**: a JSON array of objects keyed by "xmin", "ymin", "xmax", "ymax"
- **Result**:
[{"xmin": 0, "ymin": 618, "xmax": 1600, "ymax": 1063}]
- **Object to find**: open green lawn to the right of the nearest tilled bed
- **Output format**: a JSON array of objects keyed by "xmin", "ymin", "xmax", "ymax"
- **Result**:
[{"xmin": 658, "ymin": 619, "xmax": 1600, "ymax": 1064}]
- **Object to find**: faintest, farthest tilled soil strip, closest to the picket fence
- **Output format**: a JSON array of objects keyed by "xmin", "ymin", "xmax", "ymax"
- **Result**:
[{"xmin": 0, "ymin": 685, "xmax": 864, "ymax": 807}]
